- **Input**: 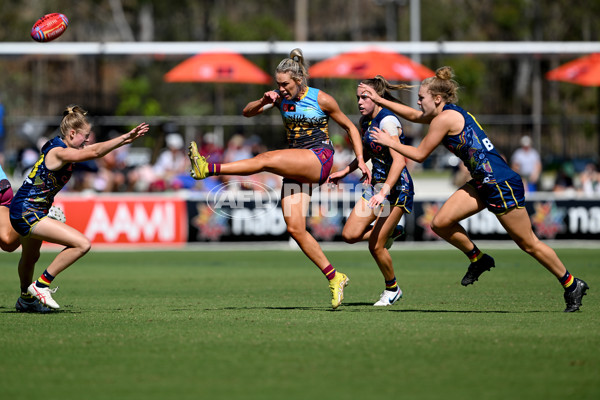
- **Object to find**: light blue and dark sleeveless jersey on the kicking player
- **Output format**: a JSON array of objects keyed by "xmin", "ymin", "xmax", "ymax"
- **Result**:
[{"xmin": 277, "ymin": 87, "xmax": 333, "ymax": 150}]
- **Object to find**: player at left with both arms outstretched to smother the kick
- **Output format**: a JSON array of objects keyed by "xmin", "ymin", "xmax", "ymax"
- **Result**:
[{"xmin": 10, "ymin": 105, "xmax": 149, "ymax": 309}]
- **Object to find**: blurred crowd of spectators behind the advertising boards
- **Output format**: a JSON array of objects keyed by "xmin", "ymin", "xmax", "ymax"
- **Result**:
[{"xmin": 0, "ymin": 127, "xmax": 600, "ymax": 197}]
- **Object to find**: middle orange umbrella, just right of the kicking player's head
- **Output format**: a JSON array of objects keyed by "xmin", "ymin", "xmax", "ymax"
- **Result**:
[{"xmin": 308, "ymin": 47, "xmax": 435, "ymax": 81}]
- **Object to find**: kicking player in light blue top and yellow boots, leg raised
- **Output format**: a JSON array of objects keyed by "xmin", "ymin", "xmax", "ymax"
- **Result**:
[{"xmin": 189, "ymin": 49, "xmax": 370, "ymax": 309}]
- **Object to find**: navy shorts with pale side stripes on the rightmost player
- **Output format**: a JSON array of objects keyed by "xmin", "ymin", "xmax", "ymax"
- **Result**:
[{"xmin": 467, "ymin": 176, "xmax": 525, "ymax": 215}]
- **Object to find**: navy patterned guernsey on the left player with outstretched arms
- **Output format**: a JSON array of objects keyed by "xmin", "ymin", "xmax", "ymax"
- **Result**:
[{"xmin": 10, "ymin": 136, "xmax": 73, "ymax": 219}]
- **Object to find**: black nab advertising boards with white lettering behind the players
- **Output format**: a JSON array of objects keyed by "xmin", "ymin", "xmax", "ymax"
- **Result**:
[{"xmin": 187, "ymin": 191, "xmax": 600, "ymax": 242}]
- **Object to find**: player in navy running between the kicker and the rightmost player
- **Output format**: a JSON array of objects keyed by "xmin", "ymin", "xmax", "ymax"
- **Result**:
[{"xmin": 328, "ymin": 76, "xmax": 414, "ymax": 306}]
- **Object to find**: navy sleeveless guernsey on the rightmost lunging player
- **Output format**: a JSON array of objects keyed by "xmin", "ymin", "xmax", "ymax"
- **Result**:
[{"xmin": 442, "ymin": 104, "xmax": 519, "ymax": 184}]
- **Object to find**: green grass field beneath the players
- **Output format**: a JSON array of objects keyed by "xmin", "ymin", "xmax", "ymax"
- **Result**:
[{"xmin": 0, "ymin": 246, "xmax": 600, "ymax": 400}]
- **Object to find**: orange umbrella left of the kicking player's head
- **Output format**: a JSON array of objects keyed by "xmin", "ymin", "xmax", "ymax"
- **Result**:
[{"xmin": 164, "ymin": 50, "xmax": 271, "ymax": 84}]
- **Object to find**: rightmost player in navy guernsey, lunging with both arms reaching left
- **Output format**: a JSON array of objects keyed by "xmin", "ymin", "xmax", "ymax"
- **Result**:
[{"xmin": 360, "ymin": 67, "xmax": 588, "ymax": 312}]
